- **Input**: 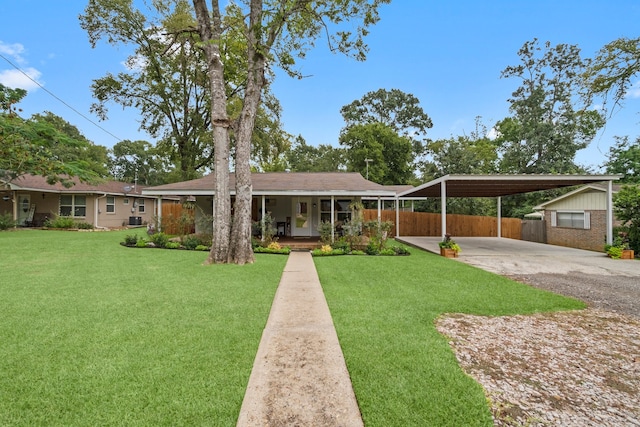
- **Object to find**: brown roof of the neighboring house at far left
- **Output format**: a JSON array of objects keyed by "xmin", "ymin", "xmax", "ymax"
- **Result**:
[{"xmin": 5, "ymin": 175, "xmax": 151, "ymax": 197}]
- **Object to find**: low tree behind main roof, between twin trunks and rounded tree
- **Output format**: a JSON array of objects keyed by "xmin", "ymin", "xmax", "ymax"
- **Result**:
[{"xmin": 286, "ymin": 136, "xmax": 347, "ymax": 172}]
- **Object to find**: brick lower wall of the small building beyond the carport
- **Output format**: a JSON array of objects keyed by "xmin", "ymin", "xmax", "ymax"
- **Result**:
[{"xmin": 545, "ymin": 211, "xmax": 607, "ymax": 252}]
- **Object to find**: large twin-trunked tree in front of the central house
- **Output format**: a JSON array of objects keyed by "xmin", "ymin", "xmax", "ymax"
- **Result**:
[{"xmin": 193, "ymin": 0, "xmax": 390, "ymax": 264}]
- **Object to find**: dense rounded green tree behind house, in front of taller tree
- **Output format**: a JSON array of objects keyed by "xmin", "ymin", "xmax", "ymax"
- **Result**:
[{"xmin": 340, "ymin": 122, "xmax": 414, "ymax": 185}]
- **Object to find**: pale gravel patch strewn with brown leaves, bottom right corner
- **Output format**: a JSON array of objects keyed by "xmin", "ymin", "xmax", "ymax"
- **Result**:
[{"xmin": 437, "ymin": 309, "xmax": 640, "ymax": 427}]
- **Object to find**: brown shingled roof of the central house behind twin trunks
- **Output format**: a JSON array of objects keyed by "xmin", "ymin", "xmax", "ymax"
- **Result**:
[{"xmin": 142, "ymin": 172, "xmax": 396, "ymax": 197}]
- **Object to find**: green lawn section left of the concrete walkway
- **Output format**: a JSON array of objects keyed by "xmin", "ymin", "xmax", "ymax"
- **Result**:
[{"xmin": 0, "ymin": 230, "xmax": 286, "ymax": 426}]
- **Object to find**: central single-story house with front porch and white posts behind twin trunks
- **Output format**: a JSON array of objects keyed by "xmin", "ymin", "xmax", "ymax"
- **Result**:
[{"xmin": 142, "ymin": 172, "xmax": 396, "ymax": 237}]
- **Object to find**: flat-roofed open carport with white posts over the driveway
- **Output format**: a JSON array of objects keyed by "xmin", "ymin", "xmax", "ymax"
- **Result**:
[{"xmin": 396, "ymin": 175, "xmax": 621, "ymax": 244}]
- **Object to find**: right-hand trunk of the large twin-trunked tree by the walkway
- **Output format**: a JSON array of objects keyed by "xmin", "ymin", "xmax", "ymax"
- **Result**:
[{"xmin": 229, "ymin": 0, "xmax": 265, "ymax": 264}]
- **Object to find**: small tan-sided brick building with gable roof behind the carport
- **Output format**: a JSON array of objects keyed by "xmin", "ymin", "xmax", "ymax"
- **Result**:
[{"xmin": 534, "ymin": 184, "xmax": 620, "ymax": 251}]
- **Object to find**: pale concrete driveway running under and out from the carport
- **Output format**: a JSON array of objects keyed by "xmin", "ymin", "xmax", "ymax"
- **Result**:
[{"xmin": 397, "ymin": 237, "xmax": 640, "ymax": 317}]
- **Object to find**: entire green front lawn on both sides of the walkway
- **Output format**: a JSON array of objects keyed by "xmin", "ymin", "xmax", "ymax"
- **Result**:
[{"xmin": 0, "ymin": 230, "xmax": 583, "ymax": 427}]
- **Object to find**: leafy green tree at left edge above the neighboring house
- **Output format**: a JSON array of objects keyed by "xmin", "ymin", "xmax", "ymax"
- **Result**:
[{"xmin": 0, "ymin": 84, "xmax": 99, "ymax": 186}]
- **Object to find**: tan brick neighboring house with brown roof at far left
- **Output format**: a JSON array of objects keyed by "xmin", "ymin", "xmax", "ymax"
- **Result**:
[{"xmin": 0, "ymin": 175, "xmax": 157, "ymax": 228}]
